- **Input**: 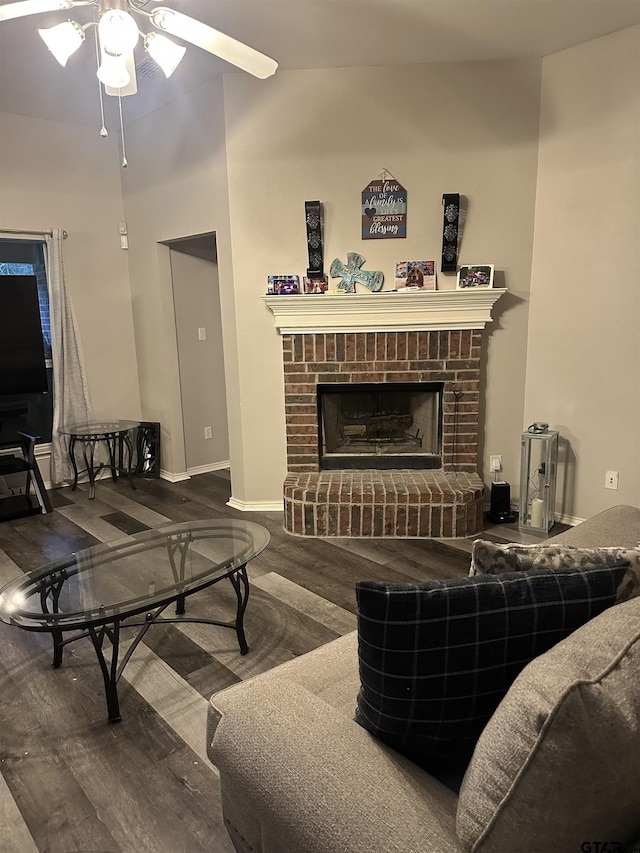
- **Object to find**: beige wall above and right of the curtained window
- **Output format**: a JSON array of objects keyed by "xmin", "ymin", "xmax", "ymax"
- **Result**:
[{"xmin": 0, "ymin": 113, "xmax": 140, "ymax": 418}]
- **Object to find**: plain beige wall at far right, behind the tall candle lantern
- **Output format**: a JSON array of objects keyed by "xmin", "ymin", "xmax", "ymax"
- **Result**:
[{"xmin": 525, "ymin": 27, "xmax": 640, "ymax": 518}]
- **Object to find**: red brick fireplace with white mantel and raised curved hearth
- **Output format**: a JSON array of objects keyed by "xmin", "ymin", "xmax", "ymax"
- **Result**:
[{"xmin": 263, "ymin": 288, "xmax": 505, "ymax": 537}]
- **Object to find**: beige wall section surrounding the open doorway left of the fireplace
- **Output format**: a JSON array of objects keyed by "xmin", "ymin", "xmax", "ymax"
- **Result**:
[{"xmin": 118, "ymin": 79, "xmax": 243, "ymax": 478}]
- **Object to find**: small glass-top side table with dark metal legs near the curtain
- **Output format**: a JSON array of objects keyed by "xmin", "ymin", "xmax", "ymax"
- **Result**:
[{"xmin": 58, "ymin": 420, "xmax": 140, "ymax": 500}]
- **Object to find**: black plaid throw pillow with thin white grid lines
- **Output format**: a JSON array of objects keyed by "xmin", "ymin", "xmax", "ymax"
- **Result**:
[{"xmin": 355, "ymin": 565, "xmax": 626, "ymax": 769}]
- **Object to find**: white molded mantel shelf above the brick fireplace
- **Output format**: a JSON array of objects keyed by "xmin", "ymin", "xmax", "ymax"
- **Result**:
[{"xmin": 262, "ymin": 287, "xmax": 507, "ymax": 335}]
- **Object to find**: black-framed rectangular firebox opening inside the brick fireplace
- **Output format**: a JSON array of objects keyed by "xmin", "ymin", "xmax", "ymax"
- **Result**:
[{"xmin": 317, "ymin": 382, "xmax": 444, "ymax": 471}]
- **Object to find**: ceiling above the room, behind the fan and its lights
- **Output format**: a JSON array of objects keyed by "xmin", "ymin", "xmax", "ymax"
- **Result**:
[{"xmin": 0, "ymin": 0, "xmax": 640, "ymax": 125}]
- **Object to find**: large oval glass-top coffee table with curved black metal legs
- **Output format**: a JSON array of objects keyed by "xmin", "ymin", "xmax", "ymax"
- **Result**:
[{"xmin": 0, "ymin": 519, "xmax": 269, "ymax": 722}]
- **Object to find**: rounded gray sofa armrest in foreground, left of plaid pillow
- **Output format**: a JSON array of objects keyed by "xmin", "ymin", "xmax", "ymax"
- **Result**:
[{"xmin": 207, "ymin": 677, "xmax": 464, "ymax": 853}]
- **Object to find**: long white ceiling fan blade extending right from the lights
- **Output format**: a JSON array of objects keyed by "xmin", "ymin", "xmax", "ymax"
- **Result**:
[{"xmin": 151, "ymin": 6, "xmax": 278, "ymax": 80}]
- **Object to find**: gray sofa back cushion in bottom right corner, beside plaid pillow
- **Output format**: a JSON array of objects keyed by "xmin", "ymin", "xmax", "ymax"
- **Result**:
[{"xmin": 456, "ymin": 598, "xmax": 640, "ymax": 853}]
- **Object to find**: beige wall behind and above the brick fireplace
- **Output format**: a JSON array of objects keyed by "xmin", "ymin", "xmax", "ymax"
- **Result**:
[{"xmin": 224, "ymin": 61, "xmax": 540, "ymax": 504}]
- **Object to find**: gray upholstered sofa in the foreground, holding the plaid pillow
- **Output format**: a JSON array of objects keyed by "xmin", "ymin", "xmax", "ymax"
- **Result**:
[{"xmin": 207, "ymin": 506, "xmax": 640, "ymax": 853}]
